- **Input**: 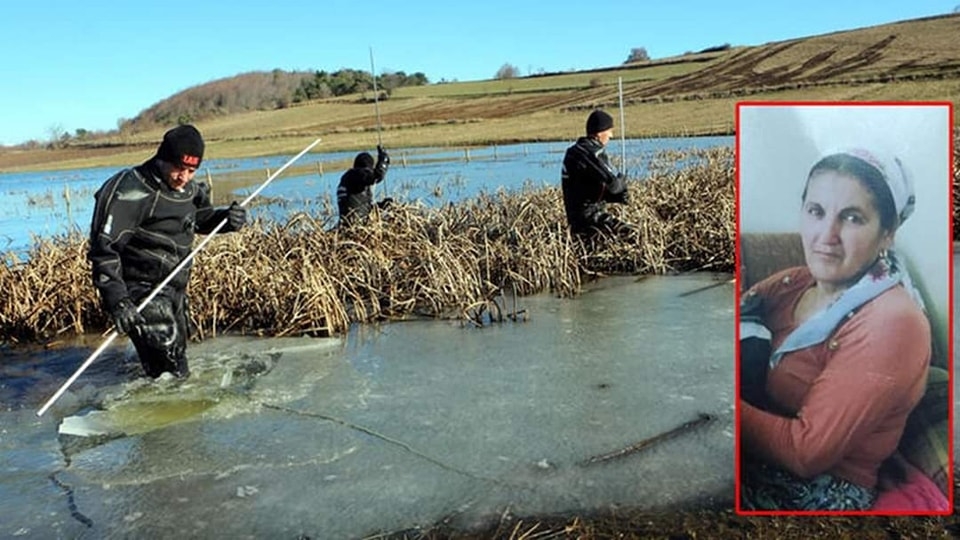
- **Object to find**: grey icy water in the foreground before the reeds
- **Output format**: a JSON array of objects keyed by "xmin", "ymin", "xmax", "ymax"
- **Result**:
[{"xmin": 0, "ymin": 274, "xmax": 734, "ymax": 538}]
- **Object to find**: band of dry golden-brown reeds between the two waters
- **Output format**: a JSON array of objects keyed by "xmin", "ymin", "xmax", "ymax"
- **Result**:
[{"xmin": 0, "ymin": 148, "xmax": 735, "ymax": 342}]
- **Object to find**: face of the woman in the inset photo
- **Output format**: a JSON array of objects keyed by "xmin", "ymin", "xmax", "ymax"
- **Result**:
[{"xmin": 800, "ymin": 171, "xmax": 894, "ymax": 287}]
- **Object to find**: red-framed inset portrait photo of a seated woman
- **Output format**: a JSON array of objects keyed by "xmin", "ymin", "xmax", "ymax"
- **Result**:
[{"xmin": 735, "ymin": 102, "xmax": 953, "ymax": 515}]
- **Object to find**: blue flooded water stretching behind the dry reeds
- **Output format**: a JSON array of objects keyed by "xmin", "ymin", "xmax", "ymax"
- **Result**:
[{"xmin": 0, "ymin": 137, "xmax": 733, "ymax": 252}]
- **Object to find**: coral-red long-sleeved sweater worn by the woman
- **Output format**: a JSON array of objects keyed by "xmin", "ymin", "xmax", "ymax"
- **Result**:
[{"xmin": 740, "ymin": 267, "xmax": 931, "ymax": 488}]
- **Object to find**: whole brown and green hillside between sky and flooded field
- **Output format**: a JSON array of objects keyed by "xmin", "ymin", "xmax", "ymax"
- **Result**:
[{"xmin": 0, "ymin": 14, "xmax": 960, "ymax": 170}]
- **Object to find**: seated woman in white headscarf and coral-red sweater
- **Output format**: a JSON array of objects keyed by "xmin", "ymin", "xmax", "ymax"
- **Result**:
[{"xmin": 740, "ymin": 149, "xmax": 931, "ymax": 511}]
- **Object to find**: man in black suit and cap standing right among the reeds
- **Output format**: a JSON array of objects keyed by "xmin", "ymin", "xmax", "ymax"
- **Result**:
[{"xmin": 560, "ymin": 109, "xmax": 635, "ymax": 236}]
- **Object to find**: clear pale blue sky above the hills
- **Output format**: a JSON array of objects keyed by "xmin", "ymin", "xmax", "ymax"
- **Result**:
[{"xmin": 0, "ymin": 0, "xmax": 960, "ymax": 145}]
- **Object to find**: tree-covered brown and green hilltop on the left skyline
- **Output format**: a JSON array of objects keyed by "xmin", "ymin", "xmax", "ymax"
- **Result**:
[{"xmin": 118, "ymin": 69, "xmax": 429, "ymax": 132}]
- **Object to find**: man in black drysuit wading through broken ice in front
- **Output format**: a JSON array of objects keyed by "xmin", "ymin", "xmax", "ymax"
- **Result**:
[{"xmin": 87, "ymin": 125, "xmax": 246, "ymax": 378}]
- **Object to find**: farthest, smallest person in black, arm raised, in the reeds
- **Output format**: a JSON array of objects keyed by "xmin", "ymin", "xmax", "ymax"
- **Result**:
[{"xmin": 337, "ymin": 146, "xmax": 393, "ymax": 226}]
